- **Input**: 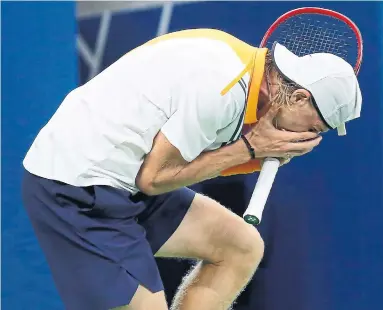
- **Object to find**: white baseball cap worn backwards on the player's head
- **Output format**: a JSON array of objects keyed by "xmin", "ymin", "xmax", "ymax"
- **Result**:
[{"xmin": 272, "ymin": 42, "xmax": 362, "ymax": 136}]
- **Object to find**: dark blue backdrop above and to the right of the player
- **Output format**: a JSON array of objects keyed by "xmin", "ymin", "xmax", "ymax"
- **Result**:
[{"xmin": 79, "ymin": 1, "xmax": 383, "ymax": 310}]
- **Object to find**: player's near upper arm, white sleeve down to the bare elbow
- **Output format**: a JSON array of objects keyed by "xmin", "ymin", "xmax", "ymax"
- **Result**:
[{"xmin": 136, "ymin": 76, "xmax": 241, "ymax": 192}]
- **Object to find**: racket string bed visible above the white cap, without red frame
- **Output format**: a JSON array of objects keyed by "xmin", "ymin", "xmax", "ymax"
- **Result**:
[{"xmin": 269, "ymin": 15, "xmax": 357, "ymax": 61}]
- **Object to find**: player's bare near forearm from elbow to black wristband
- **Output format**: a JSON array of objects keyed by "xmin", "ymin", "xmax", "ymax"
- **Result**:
[{"xmin": 138, "ymin": 140, "xmax": 250, "ymax": 195}]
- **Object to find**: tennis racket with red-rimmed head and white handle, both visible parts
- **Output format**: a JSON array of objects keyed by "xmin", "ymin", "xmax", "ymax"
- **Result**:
[{"xmin": 243, "ymin": 7, "xmax": 363, "ymax": 225}]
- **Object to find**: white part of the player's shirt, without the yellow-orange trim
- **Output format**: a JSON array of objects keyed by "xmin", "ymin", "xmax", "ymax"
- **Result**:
[{"xmin": 23, "ymin": 38, "xmax": 249, "ymax": 193}]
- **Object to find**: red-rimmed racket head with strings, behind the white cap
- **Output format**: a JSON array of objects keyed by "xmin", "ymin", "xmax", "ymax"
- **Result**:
[{"xmin": 260, "ymin": 7, "xmax": 363, "ymax": 74}]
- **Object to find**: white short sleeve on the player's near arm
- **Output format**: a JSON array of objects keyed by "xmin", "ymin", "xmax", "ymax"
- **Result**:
[{"xmin": 161, "ymin": 75, "xmax": 241, "ymax": 162}]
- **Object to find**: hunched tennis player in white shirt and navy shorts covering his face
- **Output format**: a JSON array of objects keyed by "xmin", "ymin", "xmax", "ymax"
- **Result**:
[{"xmin": 22, "ymin": 29, "xmax": 362, "ymax": 310}]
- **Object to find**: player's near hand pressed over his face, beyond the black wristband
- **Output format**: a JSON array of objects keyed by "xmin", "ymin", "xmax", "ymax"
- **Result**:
[{"xmin": 246, "ymin": 107, "xmax": 322, "ymax": 158}]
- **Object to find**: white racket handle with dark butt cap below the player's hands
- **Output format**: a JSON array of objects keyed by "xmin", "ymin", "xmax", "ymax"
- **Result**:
[{"xmin": 243, "ymin": 158, "xmax": 280, "ymax": 225}]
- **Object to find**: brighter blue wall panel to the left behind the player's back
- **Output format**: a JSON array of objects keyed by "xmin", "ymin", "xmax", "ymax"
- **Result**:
[{"xmin": 1, "ymin": 2, "xmax": 77, "ymax": 310}]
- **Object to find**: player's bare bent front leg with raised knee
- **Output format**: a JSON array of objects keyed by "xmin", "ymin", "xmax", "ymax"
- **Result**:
[{"xmin": 156, "ymin": 195, "xmax": 264, "ymax": 310}]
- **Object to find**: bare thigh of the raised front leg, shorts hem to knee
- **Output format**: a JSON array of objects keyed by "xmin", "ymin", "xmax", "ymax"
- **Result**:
[{"xmin": 156, "ymin": 194, "xmax": 260, "ymax": 263}]
